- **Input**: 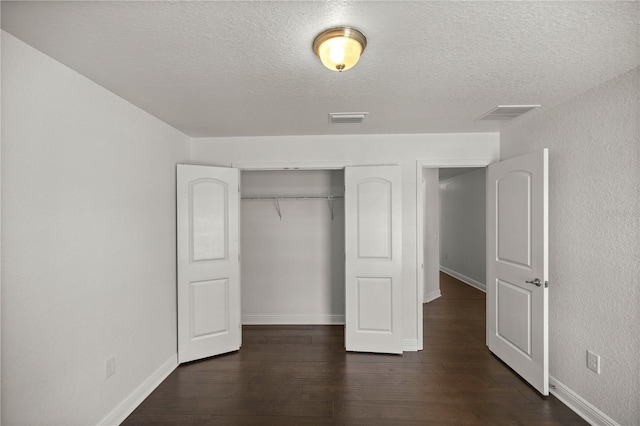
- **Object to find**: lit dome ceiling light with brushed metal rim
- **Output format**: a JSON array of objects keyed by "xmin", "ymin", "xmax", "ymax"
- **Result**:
[{"xmin": 313, "ymin": 27, "xmax": 367, "ymax": 72}]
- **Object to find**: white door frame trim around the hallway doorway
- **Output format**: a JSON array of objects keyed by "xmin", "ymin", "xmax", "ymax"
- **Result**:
[{"xmin": 416, "ymin": 158, "xmax": 492, "ymax": 350}]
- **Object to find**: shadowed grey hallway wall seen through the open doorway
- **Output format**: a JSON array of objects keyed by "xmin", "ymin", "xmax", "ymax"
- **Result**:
[{"xmin": 440, "ymin": 168, "xmax": 487, "ymax": 289}]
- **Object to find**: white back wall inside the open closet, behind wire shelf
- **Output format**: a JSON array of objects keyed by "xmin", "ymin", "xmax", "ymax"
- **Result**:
[{"xmin": 240, "ymin": 170, "xmax": 345, "ymax": 324}]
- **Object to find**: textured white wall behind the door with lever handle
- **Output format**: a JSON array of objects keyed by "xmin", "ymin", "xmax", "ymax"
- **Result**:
[{"xmin": 501, "ymin": 68, "xmax": 640, "ymax": 425}]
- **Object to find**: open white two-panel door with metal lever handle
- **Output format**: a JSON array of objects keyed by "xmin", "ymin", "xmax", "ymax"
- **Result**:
[{"xmin": 487, "ymin": 149, "xmax": 549, "ymax": 395}]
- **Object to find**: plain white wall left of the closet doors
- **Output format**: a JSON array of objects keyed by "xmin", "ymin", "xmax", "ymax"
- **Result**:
[{"xmin": 2, "ymin": 33, "xmax": 189, "ymax": 425}]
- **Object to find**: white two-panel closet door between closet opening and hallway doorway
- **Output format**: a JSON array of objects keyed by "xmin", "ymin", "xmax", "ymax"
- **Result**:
[{"xmin": 345, "ymin": 166, "xmax": 402, "ymax": 354}]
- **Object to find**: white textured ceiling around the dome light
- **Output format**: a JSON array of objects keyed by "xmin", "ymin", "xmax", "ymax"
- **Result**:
[{"xmin": 2, "ymin": 1, "xmax": 640, "ymax": 136}]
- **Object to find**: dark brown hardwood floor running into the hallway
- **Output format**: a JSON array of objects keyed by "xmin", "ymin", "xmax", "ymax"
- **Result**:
[{"xmin": 123, "ymin": 274, "xmax": 587, "ymax": 426}]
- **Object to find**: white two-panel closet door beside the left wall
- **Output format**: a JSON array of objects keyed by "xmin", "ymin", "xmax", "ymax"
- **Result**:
[{"xmin": 177, "ymin": 164, "xmax": 242, "ymax": 363}]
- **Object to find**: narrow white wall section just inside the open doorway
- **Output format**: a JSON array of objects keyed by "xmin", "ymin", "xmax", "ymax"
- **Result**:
[{"xmin": 422, "ymin": 168, "xmax": 441, "ymax": 303}]
